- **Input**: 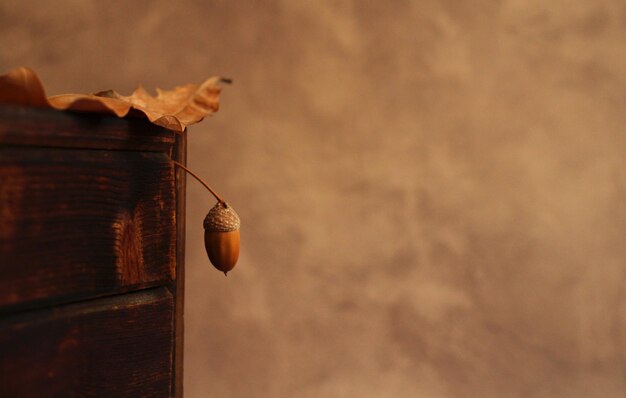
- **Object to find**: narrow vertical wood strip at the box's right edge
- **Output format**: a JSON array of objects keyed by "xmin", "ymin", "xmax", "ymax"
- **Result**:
[{"xmin": 172, "ymin": 130, "xmax": 187, "ymax": 398}]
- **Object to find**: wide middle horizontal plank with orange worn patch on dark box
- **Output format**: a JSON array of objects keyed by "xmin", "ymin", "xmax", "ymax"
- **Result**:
[{"xmin": 0, "ymin": 147, "xmax": 176, "ymax": 312}]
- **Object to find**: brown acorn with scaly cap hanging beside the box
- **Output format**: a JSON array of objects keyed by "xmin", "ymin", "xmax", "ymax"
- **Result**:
[{"xmin": 204, "ymin": 202, "xmax": 240, "ymax": 275}]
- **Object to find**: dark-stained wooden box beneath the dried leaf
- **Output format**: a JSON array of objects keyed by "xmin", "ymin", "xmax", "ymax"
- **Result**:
[{"xmin": 0, "ymin": 106, "xmax": 186, "ymax": 397}]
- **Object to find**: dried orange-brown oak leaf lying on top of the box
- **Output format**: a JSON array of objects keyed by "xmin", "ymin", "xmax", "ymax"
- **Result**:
[{"xmin": 0, "ymin": 67, "xmax": 224, "ymax": 133}]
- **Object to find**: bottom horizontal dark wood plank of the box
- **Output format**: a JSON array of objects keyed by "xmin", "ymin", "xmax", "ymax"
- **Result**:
[{"xmin": 0, "ymin": 288, "xmax": 173, "ymax": 398}]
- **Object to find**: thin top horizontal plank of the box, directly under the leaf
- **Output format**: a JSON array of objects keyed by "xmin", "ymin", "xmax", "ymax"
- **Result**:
[{"xmin": 0, "ymin": 105, "xmax": 175, "ymax": 152}]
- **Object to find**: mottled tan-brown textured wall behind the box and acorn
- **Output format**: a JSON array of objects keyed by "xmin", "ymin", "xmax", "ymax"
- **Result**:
[{"xmin": 0, "ymin": 0, "xmax": 626, "ymax": 398}]
